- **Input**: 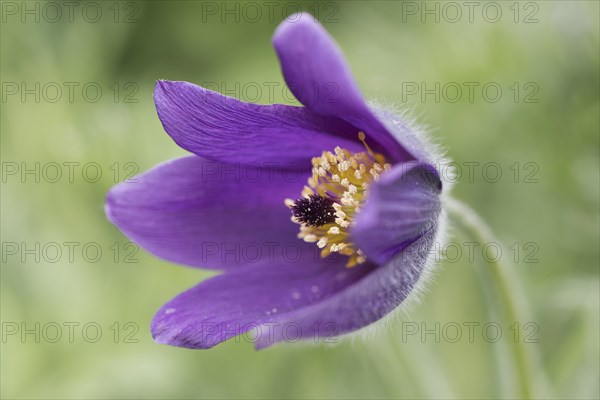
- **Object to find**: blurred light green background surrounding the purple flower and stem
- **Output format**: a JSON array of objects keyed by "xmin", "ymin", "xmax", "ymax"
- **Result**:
[{"xmin": 0, "ymin": 1, "xmax": 600, "ymax": 399}]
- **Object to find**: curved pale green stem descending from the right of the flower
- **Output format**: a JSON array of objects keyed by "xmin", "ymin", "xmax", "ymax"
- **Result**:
[{"xmin": 445, "ymin": 198, "xmax": 535, "ymax": 399}]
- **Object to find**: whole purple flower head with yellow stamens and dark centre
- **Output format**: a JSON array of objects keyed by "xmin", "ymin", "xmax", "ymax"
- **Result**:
[{"xmin": 106, "ymin": 14, "xmax": 441, "ymax": 348}]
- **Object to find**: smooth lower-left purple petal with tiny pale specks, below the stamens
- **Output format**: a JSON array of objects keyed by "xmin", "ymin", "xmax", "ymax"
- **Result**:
[{"xmin": 151, "ymin": 255, "xmax": 373, "ymax": 349}]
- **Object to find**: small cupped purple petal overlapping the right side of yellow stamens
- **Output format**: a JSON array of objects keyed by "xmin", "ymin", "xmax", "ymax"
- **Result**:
[{"xmin": 351, "ymin": 163, "xmax": 441, "ymax": 264}]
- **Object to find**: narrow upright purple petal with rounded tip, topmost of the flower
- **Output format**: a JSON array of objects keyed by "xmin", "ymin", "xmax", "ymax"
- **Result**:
[{"xmin": 273, "ymin": 13, "xmax": 415, "ymax": 162}]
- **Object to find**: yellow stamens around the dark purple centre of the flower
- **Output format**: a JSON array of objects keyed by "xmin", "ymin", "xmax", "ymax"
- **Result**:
[{"xmin": 285, "ymin": 132, "xmax": 391, "ymax": 267}]
